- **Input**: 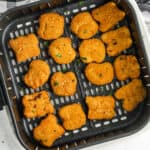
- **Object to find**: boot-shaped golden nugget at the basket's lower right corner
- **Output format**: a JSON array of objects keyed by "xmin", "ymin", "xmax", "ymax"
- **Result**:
[{"xmin": 115, "ymin": 79, "xmax": 146, "ymax": 112}]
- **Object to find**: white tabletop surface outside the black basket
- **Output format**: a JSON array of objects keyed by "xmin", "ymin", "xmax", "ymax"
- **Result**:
[{"xmin": 0, "ymin": 0, "xmax": 150, "ymax": 150}]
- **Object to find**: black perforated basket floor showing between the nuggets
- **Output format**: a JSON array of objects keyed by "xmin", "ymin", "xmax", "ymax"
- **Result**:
[{"xmin": 2, "ymin": 0, "xmax": 143, "ymax": 146}]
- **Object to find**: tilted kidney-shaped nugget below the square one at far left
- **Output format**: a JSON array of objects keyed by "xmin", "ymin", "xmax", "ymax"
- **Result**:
[{"xmin": 24, "ymin": 60, "xmax": 50, "ymax": 89}]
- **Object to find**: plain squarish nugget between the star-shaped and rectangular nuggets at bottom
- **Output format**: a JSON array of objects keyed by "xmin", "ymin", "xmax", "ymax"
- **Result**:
[{"xmin": 59, "ymin": 103, "xmax": 86, "ymax": 130}]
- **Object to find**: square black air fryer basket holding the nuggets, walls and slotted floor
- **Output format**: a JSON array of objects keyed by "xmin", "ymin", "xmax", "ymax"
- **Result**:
[{"xmin": 0, "ymin": 0, "xmax": 150, "ymax": 150}]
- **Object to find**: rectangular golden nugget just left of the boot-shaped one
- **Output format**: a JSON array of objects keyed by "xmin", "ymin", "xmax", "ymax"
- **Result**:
[{"xmin": 86, "ymin": 96, "xmax": 116, "ymax": 120}]
